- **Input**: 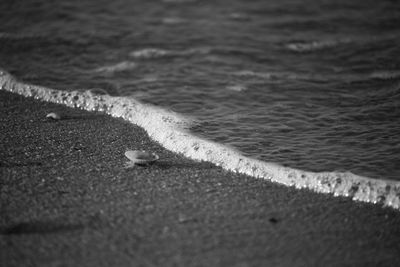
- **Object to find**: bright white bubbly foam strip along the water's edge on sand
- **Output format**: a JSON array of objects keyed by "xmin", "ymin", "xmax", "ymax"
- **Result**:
[{"xmin": 0, "ymin": 71, "xmax": 400, "ymax": 209}]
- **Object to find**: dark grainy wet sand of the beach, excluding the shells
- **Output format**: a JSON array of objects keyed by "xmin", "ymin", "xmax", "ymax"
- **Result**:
[{"xmin": 0, "ymin": 91, "xmax": 400, "ymax": 266}]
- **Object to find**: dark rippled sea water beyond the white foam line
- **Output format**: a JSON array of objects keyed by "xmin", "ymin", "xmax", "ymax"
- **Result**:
[{"xmin": 0, "ymin": 0, "xmax": 400, "ymax": 180}]
